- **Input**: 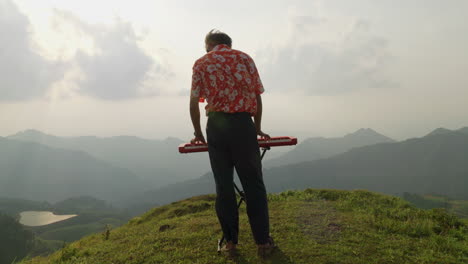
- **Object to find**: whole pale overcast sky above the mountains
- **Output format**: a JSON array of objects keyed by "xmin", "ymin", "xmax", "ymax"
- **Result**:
[{"xmin": 0, "ymin": 0, "xmax": 468, "ymax": 140}]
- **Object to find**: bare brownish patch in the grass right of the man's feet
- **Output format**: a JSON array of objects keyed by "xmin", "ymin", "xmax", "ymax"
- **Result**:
[{"xmin": 297, "ymin": 201, "xmax": 343, "ymax": 244}]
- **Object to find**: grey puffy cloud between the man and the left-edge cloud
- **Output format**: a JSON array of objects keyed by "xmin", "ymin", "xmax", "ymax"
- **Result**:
[{"xmin": 52, "ymin": 11, "xmax": 171, "ymax": 100}]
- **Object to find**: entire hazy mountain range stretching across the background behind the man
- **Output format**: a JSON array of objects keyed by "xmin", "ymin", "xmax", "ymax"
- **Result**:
[{"xmin": 0, "ymin": 128, "xmax": 468, "ymax": 209}]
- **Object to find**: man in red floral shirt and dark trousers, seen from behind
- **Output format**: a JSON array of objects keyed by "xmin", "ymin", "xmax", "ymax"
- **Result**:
[{"xmin": 190, "ymin": 30, "xmax": 275, "ymax": 256}]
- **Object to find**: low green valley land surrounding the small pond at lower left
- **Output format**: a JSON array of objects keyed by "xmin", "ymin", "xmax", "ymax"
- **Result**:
[{"xmin": 0, "ymin": 196, "xmax": 131, "ymax": 264}]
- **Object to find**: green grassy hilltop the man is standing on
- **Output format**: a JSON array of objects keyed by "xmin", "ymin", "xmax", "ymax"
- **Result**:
[{"xmin": 22, "ymin": 189, "xmax": 468, "ymax": 264}]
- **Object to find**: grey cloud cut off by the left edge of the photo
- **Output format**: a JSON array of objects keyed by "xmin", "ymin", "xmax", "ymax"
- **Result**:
[{"xmin": 0, "ymin": 0, "xmax": 62, "ymax": 101}]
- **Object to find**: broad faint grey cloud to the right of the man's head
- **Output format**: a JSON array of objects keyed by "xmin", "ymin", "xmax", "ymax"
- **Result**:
[{"xmin": 260, "ymin": 15, "xmax": 395, "ymax": 95}]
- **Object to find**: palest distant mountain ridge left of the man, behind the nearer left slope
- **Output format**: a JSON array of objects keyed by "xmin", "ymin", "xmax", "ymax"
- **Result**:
[{"xmin": 8, "ymin": 130, "xmax": 209, "ymax": 188}]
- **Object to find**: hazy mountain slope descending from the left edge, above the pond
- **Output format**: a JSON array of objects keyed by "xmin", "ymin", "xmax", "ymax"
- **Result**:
[{"xmin": 0, "ymin": 138, "xmax": 146, "ymax": 203}]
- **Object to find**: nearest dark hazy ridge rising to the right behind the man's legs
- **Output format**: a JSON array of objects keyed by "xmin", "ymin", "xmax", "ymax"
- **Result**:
[{"xmin": 136, "ymin": 128, "xmax": 468, "ymax": 208}]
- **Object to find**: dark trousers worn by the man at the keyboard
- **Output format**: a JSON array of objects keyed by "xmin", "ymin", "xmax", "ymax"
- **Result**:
[{"xmin": 206, "ymin": 112, "xmax": 270, "ymax": 244}]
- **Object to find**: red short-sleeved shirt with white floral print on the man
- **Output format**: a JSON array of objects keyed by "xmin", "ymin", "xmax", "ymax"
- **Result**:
[{"xmin": 191, "ymin": 44, "xmax": 264, "ymax": 115}]
